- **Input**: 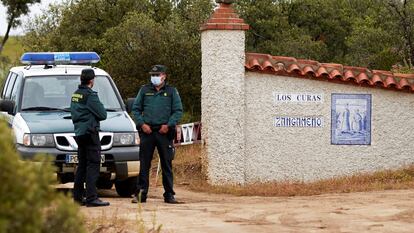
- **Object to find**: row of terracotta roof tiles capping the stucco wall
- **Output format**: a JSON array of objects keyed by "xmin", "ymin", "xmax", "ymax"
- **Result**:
[{"xmin": 245, "ymin": 53, "xmax": 414, "ymax": 92}]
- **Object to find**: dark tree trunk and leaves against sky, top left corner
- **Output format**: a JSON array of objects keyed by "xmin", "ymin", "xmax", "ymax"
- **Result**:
[{"xmin": 0, "ymin": 0, "xmax": 40, "ymax": 54}]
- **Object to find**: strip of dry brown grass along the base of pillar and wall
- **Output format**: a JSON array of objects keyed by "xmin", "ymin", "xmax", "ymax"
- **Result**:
[{"xmin": 174, "ymin": 145, "xmax": 414, "ymax": 196}]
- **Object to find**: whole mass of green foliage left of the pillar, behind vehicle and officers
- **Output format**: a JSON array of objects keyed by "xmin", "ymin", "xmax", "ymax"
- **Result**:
[{"xmin": 23, "ymin": 0, "xmax": 213, "ymax": 121}]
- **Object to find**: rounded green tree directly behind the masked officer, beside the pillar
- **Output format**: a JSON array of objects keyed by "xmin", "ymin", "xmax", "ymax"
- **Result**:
[{"xmin": 102, "ymin": 0, "xmax": 212, "ymax": 121}]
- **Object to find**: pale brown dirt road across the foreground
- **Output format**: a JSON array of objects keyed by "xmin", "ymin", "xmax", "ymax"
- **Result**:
[{"xmin": 82, "ymin": 187, "xmax": 414, "ymax": 233}]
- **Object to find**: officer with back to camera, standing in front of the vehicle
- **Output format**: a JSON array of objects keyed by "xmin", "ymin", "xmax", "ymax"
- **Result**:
[{"xmin": 70, "ymin": 69, "xmax": 109, "ymax": 207}]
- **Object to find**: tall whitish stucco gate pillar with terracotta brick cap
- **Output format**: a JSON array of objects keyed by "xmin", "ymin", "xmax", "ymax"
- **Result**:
[{"xmin": 201, "ymin": 0, "xmax": 249, "ymax": 184}]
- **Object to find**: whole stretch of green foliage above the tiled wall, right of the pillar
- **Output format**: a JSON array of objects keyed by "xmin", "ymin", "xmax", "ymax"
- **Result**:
[{"xmin": 238, "ymin": 0, "xmax": 414, "ymax": 70}]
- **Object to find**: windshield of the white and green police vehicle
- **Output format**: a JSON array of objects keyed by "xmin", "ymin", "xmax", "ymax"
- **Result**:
[{"xmin": 21, "ymin": 76, "xmax": 121, "ymax": 111}]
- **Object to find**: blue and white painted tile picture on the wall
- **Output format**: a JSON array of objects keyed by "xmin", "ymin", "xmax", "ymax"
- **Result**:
[{"xmin": 331, "ymin": 94, "xmax": 371, "ymax": 145}]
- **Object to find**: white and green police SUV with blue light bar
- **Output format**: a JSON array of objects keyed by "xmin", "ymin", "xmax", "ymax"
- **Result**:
[{"xmin": 0, "ymin": 52, "xmax": 139, "ymax": 197}]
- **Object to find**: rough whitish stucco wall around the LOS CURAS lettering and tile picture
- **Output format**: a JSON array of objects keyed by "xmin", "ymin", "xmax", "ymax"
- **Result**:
[{"xmin": 246, "ymin": 72, "xmax": 414, "ymax": 182}]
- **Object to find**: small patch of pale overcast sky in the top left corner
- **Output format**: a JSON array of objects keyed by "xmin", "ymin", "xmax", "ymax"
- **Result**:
[{"xmin": 0, "ymin": 0, "xmax": 62, "ymax": 36}]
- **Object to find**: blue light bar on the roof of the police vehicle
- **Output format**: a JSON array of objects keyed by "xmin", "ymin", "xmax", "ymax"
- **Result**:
[{"xmin": 20, "ymin": 52, "xmax": 101, "ymax": 65}]
